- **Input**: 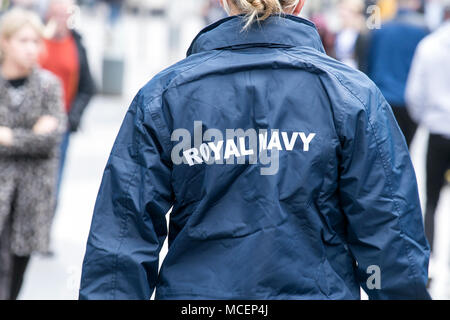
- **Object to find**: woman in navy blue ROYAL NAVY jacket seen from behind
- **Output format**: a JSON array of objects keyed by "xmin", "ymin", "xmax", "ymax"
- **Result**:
[{"xmin": 80, "ymin": 0, "xmax": 430, "ymax": 299}]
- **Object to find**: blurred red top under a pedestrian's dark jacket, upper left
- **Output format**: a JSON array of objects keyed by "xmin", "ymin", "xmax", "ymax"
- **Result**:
[{"xmin": 39, "ymin": 35, "xmax": 80, "ymax": 113}]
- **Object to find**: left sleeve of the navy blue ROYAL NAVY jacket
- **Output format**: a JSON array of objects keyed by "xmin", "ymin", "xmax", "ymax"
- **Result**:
[{"xmin": 79, "ymin": 93, "xmax": 174, "ymax": 300}]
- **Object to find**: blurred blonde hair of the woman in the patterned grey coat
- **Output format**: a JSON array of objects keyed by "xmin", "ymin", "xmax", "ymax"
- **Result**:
[{"xmin": 0, "ymin": 8, "xmax": 44, "ymax": 62}]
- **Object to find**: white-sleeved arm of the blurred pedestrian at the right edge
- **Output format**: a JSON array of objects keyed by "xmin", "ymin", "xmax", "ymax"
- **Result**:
[{"xmin": 405, "ymin": 43, "xmax": 428, "ymax": 123}]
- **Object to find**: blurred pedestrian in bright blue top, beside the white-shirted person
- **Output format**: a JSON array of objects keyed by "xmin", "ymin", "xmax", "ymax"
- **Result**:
[{"xmin": 368, "ymin": 0, "xmax": 428, "ymax": 146}]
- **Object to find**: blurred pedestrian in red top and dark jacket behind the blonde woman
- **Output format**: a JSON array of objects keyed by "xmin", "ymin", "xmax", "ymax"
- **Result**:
[{"xmin": 40, "ymin": 0, "xmax": 95, "ymax": 215}]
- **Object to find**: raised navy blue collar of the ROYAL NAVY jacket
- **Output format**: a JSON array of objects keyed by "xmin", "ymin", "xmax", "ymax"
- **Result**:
[{"xmin": 187, "ymin": 14, "xmax": 325, "ymax": 56}]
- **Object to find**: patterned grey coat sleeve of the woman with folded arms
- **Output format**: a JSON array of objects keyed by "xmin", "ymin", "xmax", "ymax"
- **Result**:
[{"xmin": 0, "ymin": 78, "xmax": 67, "ymax": 158}]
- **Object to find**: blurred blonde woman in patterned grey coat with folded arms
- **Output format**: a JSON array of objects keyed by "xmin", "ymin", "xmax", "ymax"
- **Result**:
[{"xmin": 0, "ymin": 9, "xmax": 65, "ymax": 299}]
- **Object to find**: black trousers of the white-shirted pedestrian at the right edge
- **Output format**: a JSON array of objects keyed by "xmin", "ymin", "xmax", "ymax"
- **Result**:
[{"xmin": 425, "ymin": 134, "xmax": 450, "ymax": 250}]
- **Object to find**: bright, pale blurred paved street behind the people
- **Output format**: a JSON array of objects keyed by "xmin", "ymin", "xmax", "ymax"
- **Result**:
[{"xmin": 20, "ymin": 5, "xmax": 450, "ymax": 299}]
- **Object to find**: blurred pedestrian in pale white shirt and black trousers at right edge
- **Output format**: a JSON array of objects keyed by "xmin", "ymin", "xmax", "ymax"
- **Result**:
[{"xmin": 406, "ymin": 0, "xmax": 450, "ymax": 258}]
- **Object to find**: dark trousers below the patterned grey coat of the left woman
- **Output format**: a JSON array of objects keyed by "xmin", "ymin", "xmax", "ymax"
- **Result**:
[{"xmin": 0, "ymin": 212, "xmax": 30, "ymax": 300}]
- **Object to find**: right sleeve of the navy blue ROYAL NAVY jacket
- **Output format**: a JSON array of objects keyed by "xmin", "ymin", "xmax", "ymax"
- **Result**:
[{"xmin": 339, "ymin": 88, "xmax": 430, "ymax": 299}]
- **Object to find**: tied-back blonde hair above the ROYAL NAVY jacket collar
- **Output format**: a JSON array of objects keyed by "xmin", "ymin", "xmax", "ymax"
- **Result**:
[{"xmin": 227, "ymin": 0, "xmax": 300, "ymax": 30}]
